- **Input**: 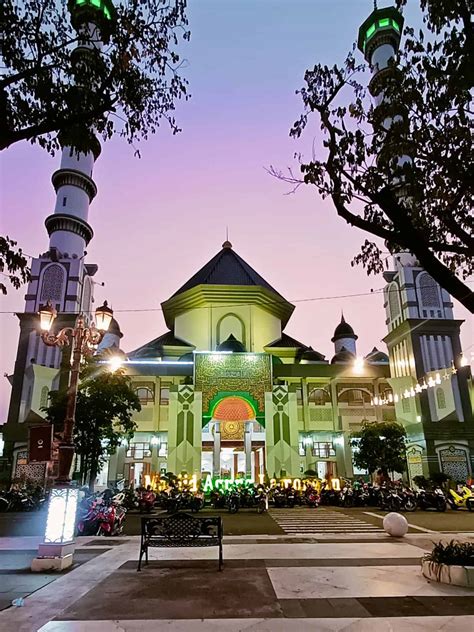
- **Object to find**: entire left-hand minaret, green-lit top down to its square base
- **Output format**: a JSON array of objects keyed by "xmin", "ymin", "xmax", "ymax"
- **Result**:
[{"xmin": 4, "ymin": 0, "xmax": 115, "ymax": 452}]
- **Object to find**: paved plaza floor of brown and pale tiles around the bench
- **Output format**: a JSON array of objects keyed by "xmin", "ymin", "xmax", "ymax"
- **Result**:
[{"xmin": 0, "ymin": 508, "xmax": 474, "ymax": 632}]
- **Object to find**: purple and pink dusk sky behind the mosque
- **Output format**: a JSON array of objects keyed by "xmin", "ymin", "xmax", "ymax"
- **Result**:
[{"xmin": 0, "ymin": 0, "xmax": 474, "ymax": 423}]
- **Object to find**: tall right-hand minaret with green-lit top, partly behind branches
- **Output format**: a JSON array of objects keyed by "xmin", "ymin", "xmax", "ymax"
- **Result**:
[{"xmin": 358, "ymin": 7, "xmax": 474, "ymax": 480}]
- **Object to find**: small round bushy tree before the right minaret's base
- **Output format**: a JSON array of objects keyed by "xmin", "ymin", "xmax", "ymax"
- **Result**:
[{"xmin": 351, "ymin": 421, "xmax": 407, "ymax": 475}]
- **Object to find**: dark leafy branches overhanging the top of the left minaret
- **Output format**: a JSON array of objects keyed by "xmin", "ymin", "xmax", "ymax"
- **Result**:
[{"xmin": 0, "ymin": 0, "xmax": 190, "ymax": 153}]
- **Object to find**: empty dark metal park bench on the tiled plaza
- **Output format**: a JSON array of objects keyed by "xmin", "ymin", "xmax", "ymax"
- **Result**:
[{"xmin": 137, "ymin": 512, "xmax": 224, "ymax": 571}]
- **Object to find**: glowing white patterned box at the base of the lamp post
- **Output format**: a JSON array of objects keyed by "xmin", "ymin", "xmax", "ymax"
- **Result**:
[{"xmin": 44, "ymin": 487, "xmax": 78, "ymax": 544}]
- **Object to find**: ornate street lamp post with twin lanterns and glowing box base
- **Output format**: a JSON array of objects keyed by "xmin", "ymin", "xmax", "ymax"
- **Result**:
[{"xmin": 31, "ymin": 301, "xmax": 113, "ymax": 572}]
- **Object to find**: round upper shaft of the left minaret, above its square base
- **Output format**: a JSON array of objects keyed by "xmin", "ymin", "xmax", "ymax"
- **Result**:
[{"xmin": 45, "ymin": 0, "xmax": 114, "ymax": 258}]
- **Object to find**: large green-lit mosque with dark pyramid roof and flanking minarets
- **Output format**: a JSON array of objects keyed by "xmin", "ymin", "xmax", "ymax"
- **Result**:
[{"xmin": 0, "ymin": 0, "xmax": 474, "ymax": 484}]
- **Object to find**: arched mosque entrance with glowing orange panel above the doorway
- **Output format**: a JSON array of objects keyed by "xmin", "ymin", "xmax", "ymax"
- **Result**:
[{"xmin": 211, "ymin": 395, "xmax": 264, "ymax": 478}]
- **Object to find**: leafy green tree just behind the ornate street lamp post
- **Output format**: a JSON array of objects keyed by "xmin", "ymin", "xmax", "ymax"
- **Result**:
[{"xmin": 42, "ymin": 358, "xmax": 141, "ymax": 489}]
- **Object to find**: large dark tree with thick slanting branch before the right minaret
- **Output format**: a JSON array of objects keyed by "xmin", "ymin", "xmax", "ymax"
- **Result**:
[{"xmin": 270, "ymin": 0, "xmax": 474, "ymax": 312}]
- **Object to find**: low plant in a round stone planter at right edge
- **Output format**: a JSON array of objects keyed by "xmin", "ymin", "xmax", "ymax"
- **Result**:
[{"xmin": 421, "ymin": 540, "xmax": 474, "ymax": 588}]
